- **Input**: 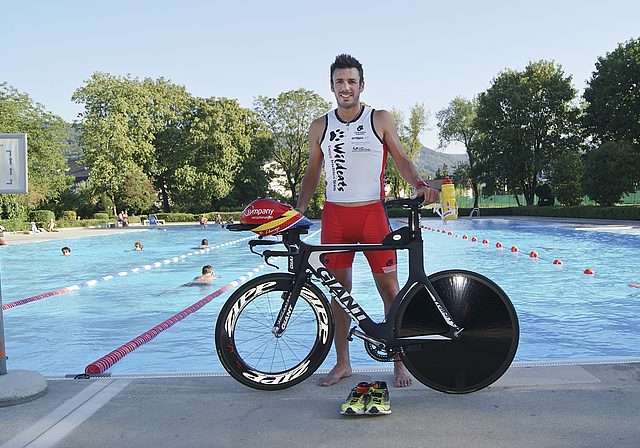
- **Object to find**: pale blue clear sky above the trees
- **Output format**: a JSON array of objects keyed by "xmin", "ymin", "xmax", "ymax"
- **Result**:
[{"xmin": 0, "ymin": 0, "xmax": 640, "ymax": 153}]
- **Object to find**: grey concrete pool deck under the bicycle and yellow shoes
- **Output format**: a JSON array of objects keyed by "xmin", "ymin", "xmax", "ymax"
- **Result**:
[{"xmin": 0, "ymin": 362, "xmax": 640, "ymax": 448}]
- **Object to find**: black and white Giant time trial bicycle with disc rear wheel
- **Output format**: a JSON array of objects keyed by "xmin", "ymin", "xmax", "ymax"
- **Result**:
[{"xmin": 215, "ymin": 198, "xmax": 519, "ymax": 393}]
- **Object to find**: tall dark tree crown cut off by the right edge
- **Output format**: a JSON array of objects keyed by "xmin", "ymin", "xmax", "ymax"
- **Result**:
[{"xmin": 583, "ymin": 39, "xmax": 640, "ymax": 145}]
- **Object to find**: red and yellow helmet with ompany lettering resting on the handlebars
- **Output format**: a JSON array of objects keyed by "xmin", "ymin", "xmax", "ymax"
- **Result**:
[{"xmin": 240, "ymin": 199, "xmax": 312, "ymax": 236}]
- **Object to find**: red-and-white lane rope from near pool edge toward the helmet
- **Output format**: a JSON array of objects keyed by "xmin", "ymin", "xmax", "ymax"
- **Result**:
[{"xmin": 81, "ymin": 229, "xmax": 321, "ymax": 378}]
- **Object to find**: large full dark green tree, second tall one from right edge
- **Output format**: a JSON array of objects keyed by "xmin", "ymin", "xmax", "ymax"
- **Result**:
[{"xmin": 474, "ymin": 61, "xmax": 577, "ymax": 205}]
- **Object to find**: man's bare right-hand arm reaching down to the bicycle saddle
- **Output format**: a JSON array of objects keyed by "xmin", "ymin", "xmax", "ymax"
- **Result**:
[{"xmin": 373, "ymin": 110, "xmax": 440, "ymax": 205}]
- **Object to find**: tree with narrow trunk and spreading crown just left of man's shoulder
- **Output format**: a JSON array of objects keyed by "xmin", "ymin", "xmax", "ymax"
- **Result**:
[{"xmin": 254, "ymin": 89, "xmax": 331, "ymax": 204}]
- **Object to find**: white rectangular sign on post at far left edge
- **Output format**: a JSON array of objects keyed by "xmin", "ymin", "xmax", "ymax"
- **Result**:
[{"xmin": 0, "ymin": 134, "xmax": 29, "ymax": 194}]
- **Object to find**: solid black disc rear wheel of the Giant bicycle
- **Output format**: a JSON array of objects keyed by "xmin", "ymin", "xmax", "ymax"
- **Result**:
[{"xmin": 396, "ymin": 270, "xmax": 519, "ymax": 393}]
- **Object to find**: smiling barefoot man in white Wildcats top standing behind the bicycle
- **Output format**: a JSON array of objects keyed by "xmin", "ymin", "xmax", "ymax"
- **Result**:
[{"xmin": 296, "ymin": 54, "xmax": 439, "ymax": 387}]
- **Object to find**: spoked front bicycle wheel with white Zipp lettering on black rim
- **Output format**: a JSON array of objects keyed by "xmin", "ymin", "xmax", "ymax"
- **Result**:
[{"xmin": 215, "ymin": 273, "xmax": 334, "ymax": 390}]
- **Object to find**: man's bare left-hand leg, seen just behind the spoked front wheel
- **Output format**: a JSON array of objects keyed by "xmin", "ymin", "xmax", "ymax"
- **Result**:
[{"xmin": 318, "ymin": 268, "xmax": 351, "ymax": 386}]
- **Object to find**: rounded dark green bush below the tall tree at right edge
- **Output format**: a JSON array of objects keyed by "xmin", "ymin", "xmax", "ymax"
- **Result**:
[{"xmin": 582, "ymin": 141, "xmax": 640, "ymax": 206}]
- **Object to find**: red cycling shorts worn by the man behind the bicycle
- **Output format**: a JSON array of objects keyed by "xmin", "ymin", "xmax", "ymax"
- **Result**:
[{"xmin": 320, "ymin": 202, "xmax": 396, "ymax": 274}]
